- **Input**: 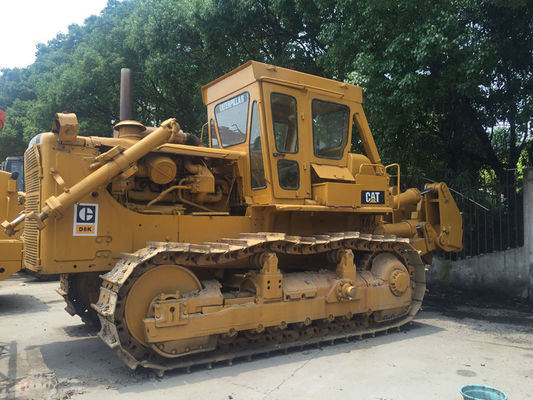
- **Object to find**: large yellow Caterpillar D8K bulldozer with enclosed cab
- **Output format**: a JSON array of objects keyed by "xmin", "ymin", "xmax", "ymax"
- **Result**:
[{"xmin": 0, "ymin": 61, "xmax": 462, "ymax": 373}]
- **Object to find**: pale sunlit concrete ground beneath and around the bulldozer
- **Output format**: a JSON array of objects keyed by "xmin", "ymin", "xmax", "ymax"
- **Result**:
[{"xmin": 0, "ymin": 275, "xmax": 533, "ymax": 400}]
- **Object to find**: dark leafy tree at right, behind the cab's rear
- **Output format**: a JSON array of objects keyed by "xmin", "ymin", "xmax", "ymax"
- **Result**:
[{"xmin": 323, "ymin": 0, "xmax": 533, "ymax": 188}]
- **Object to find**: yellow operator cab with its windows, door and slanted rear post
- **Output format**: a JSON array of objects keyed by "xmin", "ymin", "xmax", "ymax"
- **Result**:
[{"xmin": 202, "ymin": 61, "xmax": 388, "ymax": 207}]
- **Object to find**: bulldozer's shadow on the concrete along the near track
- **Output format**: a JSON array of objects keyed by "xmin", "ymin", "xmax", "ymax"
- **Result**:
[{"xmin": 29, "ymin": 322, "xmax": 442, "ymax": 393}]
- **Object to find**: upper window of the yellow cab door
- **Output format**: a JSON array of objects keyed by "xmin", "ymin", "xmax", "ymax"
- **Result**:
[{"xmin": 270, "ymin": 93, "xmax": 298, "ymax": 153}]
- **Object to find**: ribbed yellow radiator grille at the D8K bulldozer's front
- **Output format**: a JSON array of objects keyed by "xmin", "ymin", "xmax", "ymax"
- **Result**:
[{"xmin": 24, "ymin": 145, "xmax": 41, "ymax": 268}]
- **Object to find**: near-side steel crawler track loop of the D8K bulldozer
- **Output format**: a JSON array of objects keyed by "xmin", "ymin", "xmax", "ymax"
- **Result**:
[{"xmin": 92, "ymin": 232, "xmax": 426, "ymax": 374}]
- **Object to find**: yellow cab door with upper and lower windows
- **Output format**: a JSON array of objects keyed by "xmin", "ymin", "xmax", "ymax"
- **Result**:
[{"xmin": 263, "ymin": 82, "xmax": 310, "ymax": 199}]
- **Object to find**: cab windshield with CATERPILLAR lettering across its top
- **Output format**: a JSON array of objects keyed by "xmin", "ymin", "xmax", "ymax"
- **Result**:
[{"xmin": 215, "ymin": 92, "xmax": 250, "ymax": 147}]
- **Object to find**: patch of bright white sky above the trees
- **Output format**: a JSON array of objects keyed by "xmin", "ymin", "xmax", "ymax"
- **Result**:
[{"xmin": 0, "ymin": 0, "xmax": 107, "ymax": 69}]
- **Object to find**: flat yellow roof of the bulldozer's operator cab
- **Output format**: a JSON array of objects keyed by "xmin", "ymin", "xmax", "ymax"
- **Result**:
[{"xmin": 202, "ymin": 61, "xmax": 363, "ymax": 105}]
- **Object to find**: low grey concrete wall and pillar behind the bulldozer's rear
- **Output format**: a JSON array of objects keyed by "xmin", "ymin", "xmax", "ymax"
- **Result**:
[{"xmin": 427, "ymin": 169, "xmax": 533, "ymax": 299}]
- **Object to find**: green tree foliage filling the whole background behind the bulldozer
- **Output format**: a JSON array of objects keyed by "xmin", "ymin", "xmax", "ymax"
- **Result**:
[{"xmin": 0, "ymin": 0, "xmax": 533, "ymax": 189}]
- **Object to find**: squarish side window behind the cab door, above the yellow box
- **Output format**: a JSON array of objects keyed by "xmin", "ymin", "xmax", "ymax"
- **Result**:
[{"xmin": 312, "ymin": 99, "xmax": 350, "ymax": 160}]
